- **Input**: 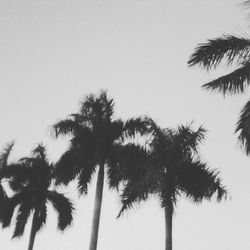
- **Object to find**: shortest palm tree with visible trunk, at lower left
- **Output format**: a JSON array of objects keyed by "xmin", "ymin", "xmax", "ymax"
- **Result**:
[{"xmin": 2, "ymin": 144, "xmax": 73, "ymax": 250}]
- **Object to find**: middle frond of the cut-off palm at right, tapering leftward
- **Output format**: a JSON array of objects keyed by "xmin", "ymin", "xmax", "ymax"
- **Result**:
[{"xmin": 202, "ymin": 62, "xmax": 250, "ymax": 95}]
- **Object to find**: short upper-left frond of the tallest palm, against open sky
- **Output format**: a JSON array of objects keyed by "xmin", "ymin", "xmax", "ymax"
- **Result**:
[{"xmin": 52, "ymin": 119, "xmax": 80, "ymax": 137}]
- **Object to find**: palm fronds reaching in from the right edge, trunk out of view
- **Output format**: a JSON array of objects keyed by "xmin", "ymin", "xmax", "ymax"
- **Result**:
[{"xmin": 188, "ymin": 33, "xmax": 250, "ymax": 154}]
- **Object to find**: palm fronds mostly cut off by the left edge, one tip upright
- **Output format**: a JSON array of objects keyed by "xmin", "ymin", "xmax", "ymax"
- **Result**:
[{"xmin": 0, "ymin": 141, "xmax": 14, "ymax": 221}]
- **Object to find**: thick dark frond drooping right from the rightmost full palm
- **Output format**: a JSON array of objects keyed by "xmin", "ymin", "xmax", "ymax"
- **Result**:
[{"xmin": 177, "ymin": 159, "xmax": 227, "ymax": 203}]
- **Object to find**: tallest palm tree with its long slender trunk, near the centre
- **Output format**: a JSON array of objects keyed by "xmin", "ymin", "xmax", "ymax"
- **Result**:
[{"xmin": 53, "ymin": 91, "xmax": 151, "ymax": 250}]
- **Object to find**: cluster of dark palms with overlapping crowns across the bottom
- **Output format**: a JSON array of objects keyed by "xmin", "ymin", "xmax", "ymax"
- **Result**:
[{"xmin": 0, "ymin": 91, "xmax": 226, "ymax": 250}]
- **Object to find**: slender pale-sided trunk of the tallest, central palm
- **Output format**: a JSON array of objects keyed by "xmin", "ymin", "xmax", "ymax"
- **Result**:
[{"xmin": 89, "ymin": 163, "xmax": 104, "ymax": 250}]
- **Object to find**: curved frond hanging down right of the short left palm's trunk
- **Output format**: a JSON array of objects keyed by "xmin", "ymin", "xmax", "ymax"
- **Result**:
[{"xmin": 48, "ymin": 191, "xmax": 74, "ymax": 231}]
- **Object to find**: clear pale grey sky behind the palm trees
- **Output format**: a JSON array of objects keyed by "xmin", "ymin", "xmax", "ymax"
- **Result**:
[{"xmin": 0, "ymin": 0, "xmax": 250, "ymax": 250}]
